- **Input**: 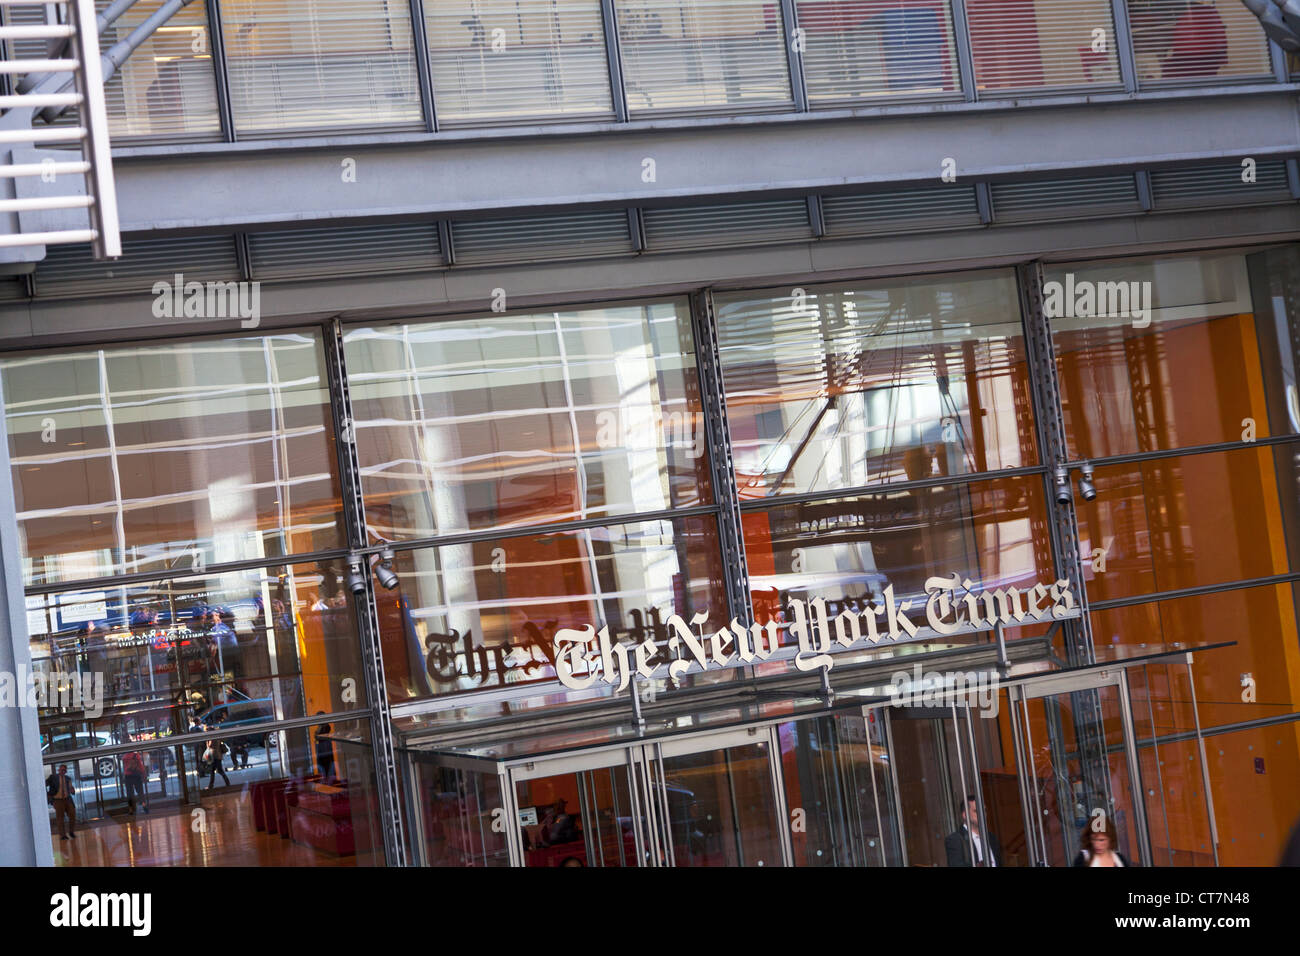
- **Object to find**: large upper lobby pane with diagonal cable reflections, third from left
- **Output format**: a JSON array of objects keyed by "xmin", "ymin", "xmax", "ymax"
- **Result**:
[{"xmin": 718, "ymin": 273, "xmax": 1037, "ymax": 498}]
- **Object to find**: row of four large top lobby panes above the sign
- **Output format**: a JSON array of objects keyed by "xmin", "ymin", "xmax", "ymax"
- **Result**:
[{"xmin": 0, "ymin": 248, "xmax": 1300, "ymax": 585}]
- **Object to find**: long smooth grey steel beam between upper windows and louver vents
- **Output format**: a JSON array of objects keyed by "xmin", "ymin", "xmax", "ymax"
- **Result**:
[{"xmin": 48, "ymin": 87, "xmax": 1300, "ymax": 233}]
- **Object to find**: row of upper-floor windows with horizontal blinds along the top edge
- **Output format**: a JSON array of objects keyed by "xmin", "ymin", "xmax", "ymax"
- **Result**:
[{"xmin": 86, "ymin": 0, "xmax": 1271, "ymax": 138}]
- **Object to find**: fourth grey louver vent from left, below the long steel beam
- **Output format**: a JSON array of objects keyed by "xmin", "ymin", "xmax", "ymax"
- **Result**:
[{"xmin": 642, "ymin": 199, "xmax": 813, "ymax": 252}]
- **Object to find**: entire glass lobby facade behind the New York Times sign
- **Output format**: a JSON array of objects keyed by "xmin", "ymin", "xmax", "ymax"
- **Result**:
[{"xmin": 10, "ymin": 247, "xmax": 1300, "ymax": 866}]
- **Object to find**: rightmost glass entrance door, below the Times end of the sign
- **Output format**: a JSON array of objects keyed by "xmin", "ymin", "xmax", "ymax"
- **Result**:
[{"xmin": 1010, "ymin": 671, "xmax": 1151, "ymax": 866}]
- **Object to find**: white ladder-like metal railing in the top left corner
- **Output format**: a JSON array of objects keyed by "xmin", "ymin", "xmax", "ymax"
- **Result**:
[{"xmin": 0, "ymin": 0, "xmax": 122, "ymax": 263}]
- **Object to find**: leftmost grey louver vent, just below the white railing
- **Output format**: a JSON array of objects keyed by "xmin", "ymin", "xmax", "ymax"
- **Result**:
[{"xmin": 36, "ymin": 235, "xmax": 239, "ymax": 298}]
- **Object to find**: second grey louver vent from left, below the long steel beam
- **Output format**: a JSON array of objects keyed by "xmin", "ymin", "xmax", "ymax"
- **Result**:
[{"xmin": 248, "ymin": 222, "xmax": 442, "ymax": 280}]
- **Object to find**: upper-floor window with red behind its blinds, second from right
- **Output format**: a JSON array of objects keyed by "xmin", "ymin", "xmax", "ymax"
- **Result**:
[{"xmin": 966, "ymin": 0, "xmax": 1119, "ymax": 96}]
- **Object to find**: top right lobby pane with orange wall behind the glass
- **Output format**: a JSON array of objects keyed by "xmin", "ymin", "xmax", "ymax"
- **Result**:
[{"xmin": 1048, "ymin": 255, "xmax": 1300, "ymax": 458}]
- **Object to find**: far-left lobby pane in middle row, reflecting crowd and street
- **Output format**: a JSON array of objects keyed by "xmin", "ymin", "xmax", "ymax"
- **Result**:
[{"xmin": 27, "ymin": 561, "xmax": 365, "ymax": 723}]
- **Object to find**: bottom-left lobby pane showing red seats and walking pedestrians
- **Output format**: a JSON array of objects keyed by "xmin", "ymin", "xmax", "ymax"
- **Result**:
[{"xmin": 44, "ymin": 721, "xmax": 384, "ymax": 866}]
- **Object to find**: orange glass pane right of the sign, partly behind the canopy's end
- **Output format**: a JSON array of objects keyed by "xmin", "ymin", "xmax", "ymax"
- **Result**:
[{"xmin": 1092, "ymin": 584, "xmax": 1300, "ymax": 732}]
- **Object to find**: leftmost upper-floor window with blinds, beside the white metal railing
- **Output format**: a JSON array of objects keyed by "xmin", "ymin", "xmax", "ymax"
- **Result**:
[{"xmin": 95, "ymin": 0, "xmax": 221, "ymax": 142}]
